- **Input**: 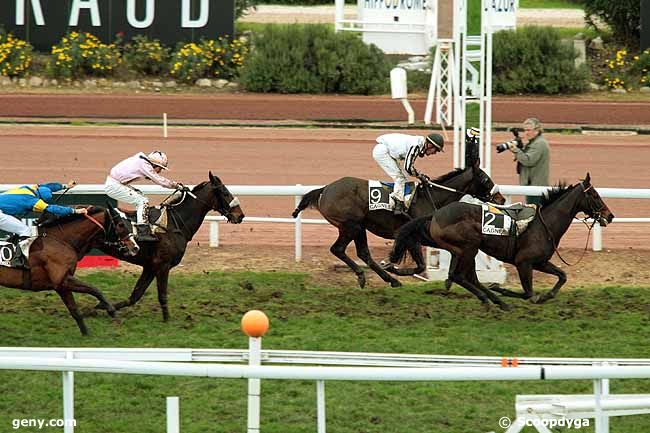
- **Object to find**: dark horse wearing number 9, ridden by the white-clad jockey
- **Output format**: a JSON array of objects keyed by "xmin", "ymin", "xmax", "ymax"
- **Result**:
[{"xmin": 292, "ymin": 161, "xmax": 505, "ymax": 287}]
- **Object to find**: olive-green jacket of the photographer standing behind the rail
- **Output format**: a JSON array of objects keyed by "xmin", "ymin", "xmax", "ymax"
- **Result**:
[{"xmin": 513, "ymin": 133, "xmax": 551, "ymax": 186}]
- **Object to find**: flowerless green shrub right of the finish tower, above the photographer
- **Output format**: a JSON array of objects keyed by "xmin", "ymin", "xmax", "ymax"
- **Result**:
[{"xmin": 493, "ymin": 26, "xmax": 589, "ymax": 94}]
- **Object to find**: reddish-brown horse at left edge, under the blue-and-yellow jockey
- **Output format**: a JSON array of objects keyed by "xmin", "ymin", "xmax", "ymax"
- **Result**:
[{"xmin": 0, "ymin": 206, "xmax": 138, "ymax": 335}]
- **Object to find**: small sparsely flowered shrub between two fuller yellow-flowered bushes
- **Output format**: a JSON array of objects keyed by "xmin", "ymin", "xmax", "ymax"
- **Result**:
[{"xmin": 123, "ymin": 35, "xmax": 170, "ymax": 75}]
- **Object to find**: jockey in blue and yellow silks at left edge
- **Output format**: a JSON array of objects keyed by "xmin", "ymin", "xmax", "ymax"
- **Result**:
[{"xmin": 0, "ymin": 181, "xmax": 88, "ymax": 256}]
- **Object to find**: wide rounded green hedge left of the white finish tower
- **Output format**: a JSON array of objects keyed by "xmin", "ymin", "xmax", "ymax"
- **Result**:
[{"xmin": 241, "ymin": 24, "xmax": 390, "ymax": 94}]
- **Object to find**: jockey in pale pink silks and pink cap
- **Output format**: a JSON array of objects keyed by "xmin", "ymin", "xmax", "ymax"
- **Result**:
[{"xmin": 104, "ymin": 150, "xmax": 182, "ymax": 241}]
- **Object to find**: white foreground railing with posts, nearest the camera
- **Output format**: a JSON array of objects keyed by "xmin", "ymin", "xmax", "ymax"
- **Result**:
[{"xmin": 0, "ymin": 344, "xmax": 650, "ymax": 433}]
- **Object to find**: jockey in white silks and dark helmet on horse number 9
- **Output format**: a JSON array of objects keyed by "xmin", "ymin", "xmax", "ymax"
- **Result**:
[{"xmin": 372, "ymin": 133, "xmax": 445, "ymax": 215}]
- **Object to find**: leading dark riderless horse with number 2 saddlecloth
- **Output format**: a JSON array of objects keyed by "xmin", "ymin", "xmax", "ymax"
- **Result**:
[{"xmin": 386, "ymin": 173, "xmax": 614, "ymax": 309}]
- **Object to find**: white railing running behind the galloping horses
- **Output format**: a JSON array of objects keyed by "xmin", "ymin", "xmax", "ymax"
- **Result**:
[{"xmin": 0, "ymin": 184, "xmax": 650, "ymax": 262}]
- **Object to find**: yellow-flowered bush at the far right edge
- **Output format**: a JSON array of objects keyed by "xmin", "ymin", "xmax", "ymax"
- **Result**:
[{"xmin": 604, "ymin": 49, "xmax": 650, "ymax": 90}]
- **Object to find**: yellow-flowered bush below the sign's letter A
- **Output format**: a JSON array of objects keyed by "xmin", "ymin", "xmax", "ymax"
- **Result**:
[{"xmin": 49, "ymin": 32, "xmax": 121, "ymax": 78}]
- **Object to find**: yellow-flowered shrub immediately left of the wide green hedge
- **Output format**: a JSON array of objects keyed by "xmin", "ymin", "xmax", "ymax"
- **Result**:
[{"xmin": 170, "ymin": 38, "xmax": 248, "ymax": 82}]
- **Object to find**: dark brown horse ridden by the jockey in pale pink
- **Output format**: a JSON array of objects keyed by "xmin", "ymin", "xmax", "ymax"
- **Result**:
[{"xmin": 98, "ymin": 172, "xmax": 244, "ymax": 321}]
